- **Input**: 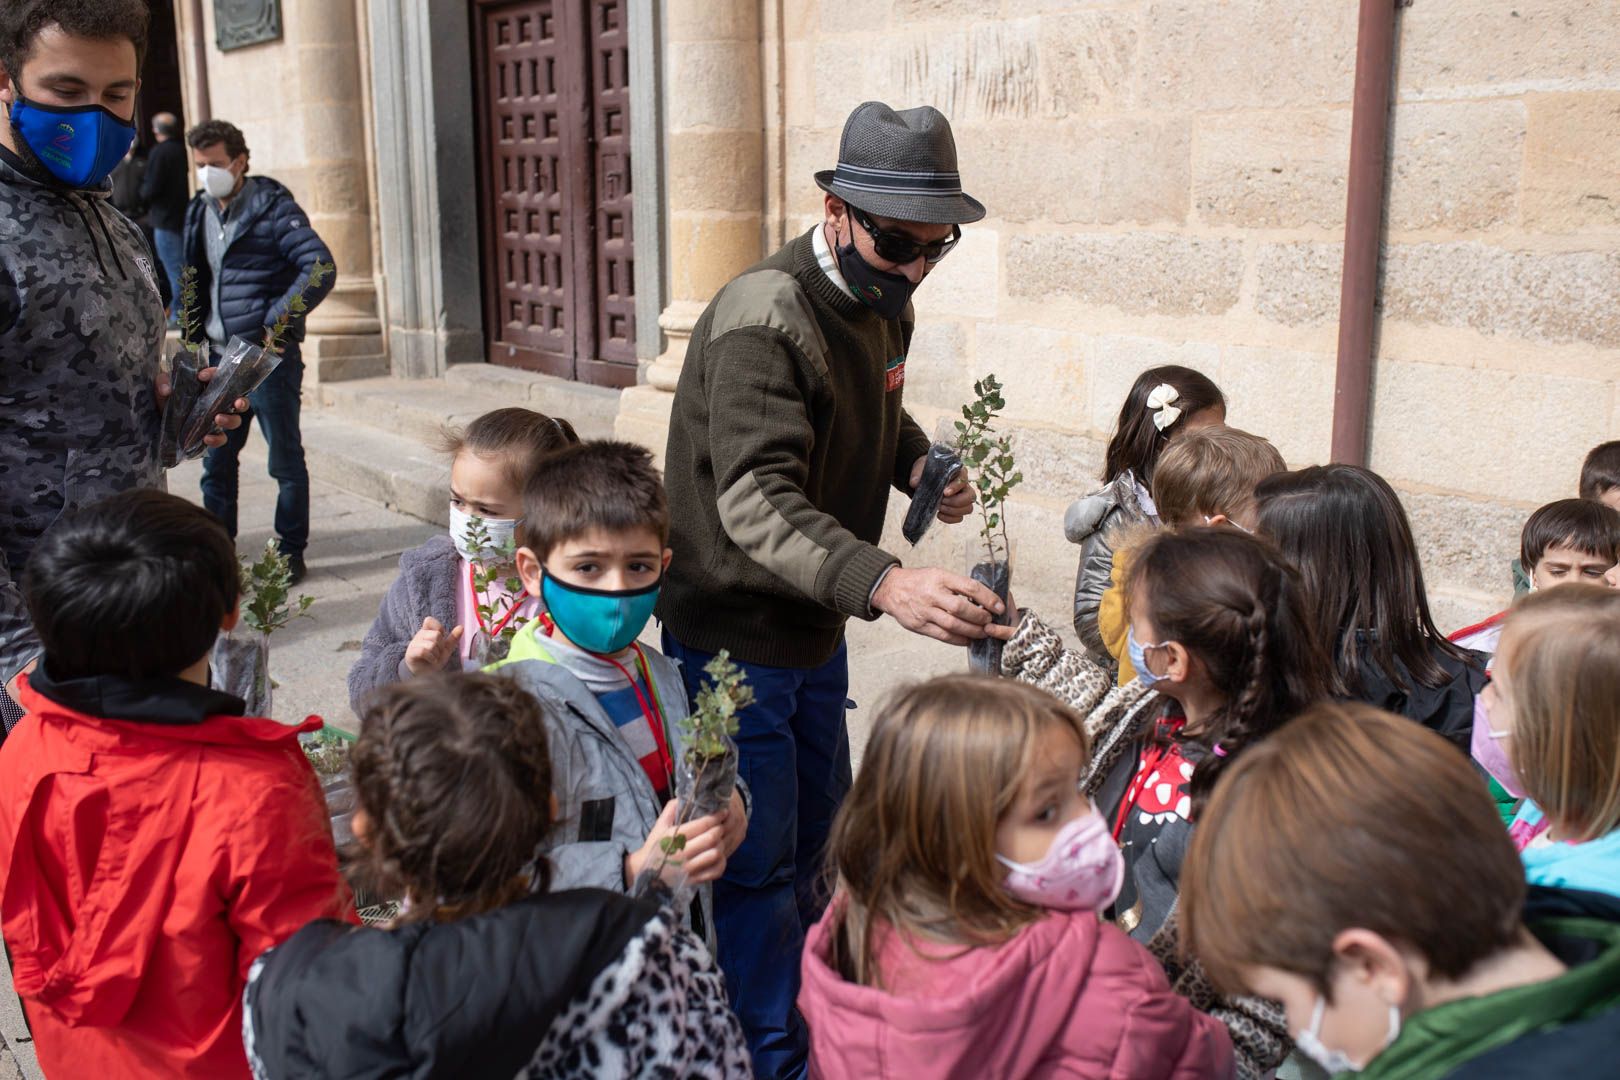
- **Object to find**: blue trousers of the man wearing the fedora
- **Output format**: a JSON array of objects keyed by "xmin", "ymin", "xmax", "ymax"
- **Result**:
[{"xmin": 664, "ymin": 630, "xmax": 851, "ymax": 1080}]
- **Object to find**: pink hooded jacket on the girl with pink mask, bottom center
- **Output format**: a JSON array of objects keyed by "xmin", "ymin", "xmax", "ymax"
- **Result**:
[{"xmin": 799, "ymin": 904, "xmax": 1233, "ymax": 1080}]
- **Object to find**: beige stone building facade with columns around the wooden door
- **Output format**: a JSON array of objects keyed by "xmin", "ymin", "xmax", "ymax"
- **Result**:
[{"xmin": 167, "ymin": 0, "xmax": 1620, "ymax": 627}]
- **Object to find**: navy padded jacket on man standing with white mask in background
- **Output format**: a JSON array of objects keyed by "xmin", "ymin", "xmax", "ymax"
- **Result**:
[{"xmin": 181, "ymin": 176, "xmax": 337, "ymax": 351}]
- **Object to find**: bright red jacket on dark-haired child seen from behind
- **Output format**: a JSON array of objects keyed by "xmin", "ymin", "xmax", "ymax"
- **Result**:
[{"xmin": 0, "ymin": 674, "xmax": 355, "ymax": 1080}]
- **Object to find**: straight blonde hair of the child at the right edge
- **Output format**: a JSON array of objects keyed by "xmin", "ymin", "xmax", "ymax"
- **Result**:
[{"xmin": 1499, "ymin": 583, "xmax": 1620, "ymax": 842}]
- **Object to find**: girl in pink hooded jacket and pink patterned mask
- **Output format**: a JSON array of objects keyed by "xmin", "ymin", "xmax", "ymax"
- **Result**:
[{"xmin": 799, "ymin": 677, "xmax": 1233, "ymax": 1080}]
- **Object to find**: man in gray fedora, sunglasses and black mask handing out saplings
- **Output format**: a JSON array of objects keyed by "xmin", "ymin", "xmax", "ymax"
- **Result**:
[{"xmin": 658, "ymin": 102, "xmax": 1011, "ymax": 1077}]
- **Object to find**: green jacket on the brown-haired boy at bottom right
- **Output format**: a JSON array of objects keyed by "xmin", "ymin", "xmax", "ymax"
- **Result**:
[{"xmin": 1359, "ymin": 918, "xmax": 1620, "ymax": 1080}]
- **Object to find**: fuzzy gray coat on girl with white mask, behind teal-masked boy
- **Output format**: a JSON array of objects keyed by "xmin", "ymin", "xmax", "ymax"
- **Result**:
[{"xmin": 348, "ymin": 534, "xmax": 462, "ymax": 716}]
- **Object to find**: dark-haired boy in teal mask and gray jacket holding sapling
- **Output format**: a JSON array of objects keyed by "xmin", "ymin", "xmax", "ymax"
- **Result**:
[{"xmin": 488, "ymin": 442, "xmax": 748, "ymax": 947}]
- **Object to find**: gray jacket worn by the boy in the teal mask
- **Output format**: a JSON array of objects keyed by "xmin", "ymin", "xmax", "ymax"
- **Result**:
[{"xmin": 488, "ymin": 628, "xmax": 748, "ymax": 950}]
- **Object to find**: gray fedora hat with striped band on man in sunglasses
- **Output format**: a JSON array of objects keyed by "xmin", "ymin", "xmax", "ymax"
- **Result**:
[{"xmin": 815, "ymin": 102, "xmax": 985, "ymax": 225}]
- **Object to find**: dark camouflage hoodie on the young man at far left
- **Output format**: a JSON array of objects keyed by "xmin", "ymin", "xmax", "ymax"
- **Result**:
[{"xmin": 0, "ymin": 149, "xmax": 164, "ymax": 682}]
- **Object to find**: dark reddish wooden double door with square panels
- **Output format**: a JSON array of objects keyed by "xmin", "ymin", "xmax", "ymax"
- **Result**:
[{"xmin": 471, "ymin": 0, "xmax": 635, "ymax": 387}]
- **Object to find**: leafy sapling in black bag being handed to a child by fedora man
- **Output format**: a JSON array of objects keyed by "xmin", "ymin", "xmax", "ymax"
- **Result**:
[{"xmin": 956, "ymin": 376, "xmax": 1024, "ymax": 675}]
